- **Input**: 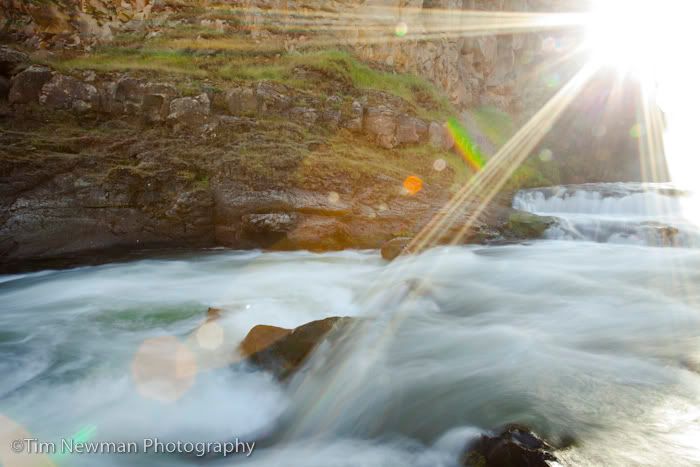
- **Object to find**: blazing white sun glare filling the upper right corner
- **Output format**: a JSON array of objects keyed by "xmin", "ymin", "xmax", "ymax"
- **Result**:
[{"xmin": 585, "ymin": 0, "xmax": 700, "ymax": 196}]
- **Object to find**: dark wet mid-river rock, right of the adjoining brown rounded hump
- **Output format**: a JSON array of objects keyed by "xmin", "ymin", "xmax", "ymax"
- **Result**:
[{"xmin": 244, "ymin": 317, "xmax": 353, "ymax": 380}]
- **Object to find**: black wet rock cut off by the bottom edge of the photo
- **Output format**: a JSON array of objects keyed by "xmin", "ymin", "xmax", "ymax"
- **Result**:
[{"xmin": 461, "ymin": 425, "xmax": 557, "ymax": 467}]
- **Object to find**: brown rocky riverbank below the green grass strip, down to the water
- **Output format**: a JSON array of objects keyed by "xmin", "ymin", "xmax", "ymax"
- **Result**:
[{"xmin": 0, "ymin": 41, "xmax": 556, "ymax": 271}]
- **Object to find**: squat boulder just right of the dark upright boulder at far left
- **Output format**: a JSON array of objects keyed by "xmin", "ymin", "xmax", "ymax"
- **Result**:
[{"xmin": 39, "ymin": 74, "xmax": 99, "ymax": 112}]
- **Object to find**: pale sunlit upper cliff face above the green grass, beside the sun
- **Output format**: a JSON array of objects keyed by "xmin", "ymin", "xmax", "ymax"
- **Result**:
[{"xmin": 233, "ymin": 0, "xmax": 586, "ymax": 115}]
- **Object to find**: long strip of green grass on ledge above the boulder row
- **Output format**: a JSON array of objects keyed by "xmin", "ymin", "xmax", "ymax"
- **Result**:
[{"xmin": 48, "ymin": 35, "xmax": 453, "ymax": 118}]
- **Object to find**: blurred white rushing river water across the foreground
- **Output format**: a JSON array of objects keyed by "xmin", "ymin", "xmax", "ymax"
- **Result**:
[{"xmin": 0, "ymin": 187, "xmax": 700, "ymax": 467}]
